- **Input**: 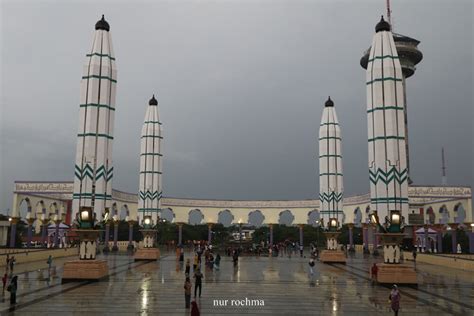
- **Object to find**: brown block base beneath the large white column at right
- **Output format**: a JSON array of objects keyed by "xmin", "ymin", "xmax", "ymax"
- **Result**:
[{"xmin": 376, "ymin": 263, "xmax": 418, "ymax": 285}]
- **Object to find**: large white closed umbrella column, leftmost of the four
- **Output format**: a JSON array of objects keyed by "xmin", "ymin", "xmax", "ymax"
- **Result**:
[{"xmin": 73, "ymin": 16, "xmax": 117, "ymax": 220}]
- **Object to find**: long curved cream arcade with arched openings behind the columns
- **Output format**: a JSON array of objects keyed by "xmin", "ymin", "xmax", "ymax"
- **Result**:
[{"xmin": 12, "ymin": 181, "xmax": 473, "ymax": 231}]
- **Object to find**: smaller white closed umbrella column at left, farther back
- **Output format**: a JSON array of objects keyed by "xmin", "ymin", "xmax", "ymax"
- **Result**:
[{"xmin": 138, "ymin": 95, "xmax": 163, "ymax": 224}]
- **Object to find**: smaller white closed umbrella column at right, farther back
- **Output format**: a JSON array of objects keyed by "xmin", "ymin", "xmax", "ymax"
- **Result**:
[{"xmin": 319, "ymin": 97, "xmax": 344, "ymax": 232}]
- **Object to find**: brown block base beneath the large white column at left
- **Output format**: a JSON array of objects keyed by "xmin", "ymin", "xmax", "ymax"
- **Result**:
[{"xmin": 62, "ymin": 260, "xmax": 109, "ymax": 283}]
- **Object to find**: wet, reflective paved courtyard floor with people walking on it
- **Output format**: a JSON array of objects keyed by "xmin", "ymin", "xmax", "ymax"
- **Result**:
[{"xmin": 0, "ymin": 253, "xmax": 474, "ymax": 316}]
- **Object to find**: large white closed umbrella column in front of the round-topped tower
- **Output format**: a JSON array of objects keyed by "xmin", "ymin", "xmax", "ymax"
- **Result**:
[{"xmin": 366, "ymin": 17, "xmax": 408, "ymax": 223}]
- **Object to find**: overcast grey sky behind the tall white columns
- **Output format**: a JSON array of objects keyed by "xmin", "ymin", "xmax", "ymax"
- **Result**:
[{"xmin": 0, "ymin": 0, "xmax": 474, "ymax": 210}]
